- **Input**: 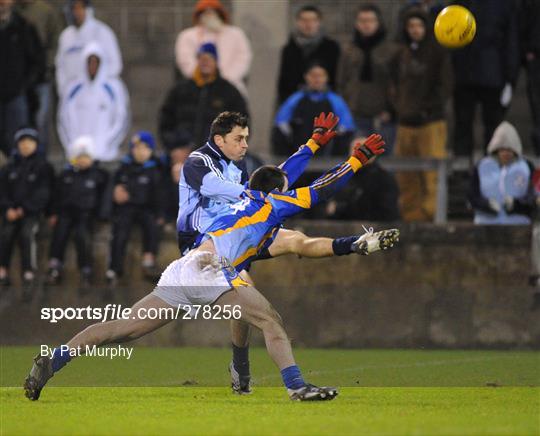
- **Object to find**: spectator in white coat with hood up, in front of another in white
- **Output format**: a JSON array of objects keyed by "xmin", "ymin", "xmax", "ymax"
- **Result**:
[{"xmin": 58, "ymin": 42, "xmax": 130, "ymax": 161}]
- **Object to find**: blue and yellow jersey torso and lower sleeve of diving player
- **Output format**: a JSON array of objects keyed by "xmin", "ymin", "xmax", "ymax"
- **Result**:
[{"xmin": 198, "ymin": 157, "xmax": 362, "ymax": 271}]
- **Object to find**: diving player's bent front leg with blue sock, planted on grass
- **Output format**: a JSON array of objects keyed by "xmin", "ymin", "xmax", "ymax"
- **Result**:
[{"xmin": 214, "ymin": 286, "xmax": 337, "ymax": 401}]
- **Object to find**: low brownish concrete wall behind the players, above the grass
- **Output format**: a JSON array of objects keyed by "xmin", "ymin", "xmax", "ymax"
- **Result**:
[{"xmin": 0, "ymin": 221, "xmax": 540, "ymax": 348}]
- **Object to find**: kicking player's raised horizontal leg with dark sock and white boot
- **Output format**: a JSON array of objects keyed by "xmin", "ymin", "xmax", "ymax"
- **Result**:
[{"xmin": 268, "ymin": 228, "xmax": 399, "ymax": 258}]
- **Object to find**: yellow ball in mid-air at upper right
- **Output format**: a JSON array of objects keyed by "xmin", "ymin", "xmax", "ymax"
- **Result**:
[{"xmin": 434, "ymin": 5, "xmax": 476, "ymax": 48}]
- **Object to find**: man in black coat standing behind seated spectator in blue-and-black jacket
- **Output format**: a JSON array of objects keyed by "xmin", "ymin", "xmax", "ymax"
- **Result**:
[{"xmin": 278, "ymin": 6, "xmax": 340, "ymax": 104}]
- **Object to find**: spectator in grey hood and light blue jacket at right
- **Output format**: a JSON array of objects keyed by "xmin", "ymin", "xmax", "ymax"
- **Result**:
[{"xmin": 469, "ymin": 121, "xmax": 536, "ymax": 225}]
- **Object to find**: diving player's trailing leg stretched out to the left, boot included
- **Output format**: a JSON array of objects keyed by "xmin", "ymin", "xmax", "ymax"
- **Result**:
[{"xmin": 24, "ymin": 294, "xmax": 173, "ymax": 400}]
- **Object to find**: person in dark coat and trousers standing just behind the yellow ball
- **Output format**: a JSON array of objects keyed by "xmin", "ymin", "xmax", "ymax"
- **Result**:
[{"xmin": 453, "ymin": 0, "xmax": 519, "ymax": 156}]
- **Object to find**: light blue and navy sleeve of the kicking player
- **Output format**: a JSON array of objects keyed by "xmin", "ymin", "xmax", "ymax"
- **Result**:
[{"xmin": 182, "ymin": 157, "xmax": 244, "ymax": 202}]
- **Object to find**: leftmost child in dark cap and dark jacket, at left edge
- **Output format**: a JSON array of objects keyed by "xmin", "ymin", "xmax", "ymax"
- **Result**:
[{"xmin": 0, "ymin": 128, "xmax": 54, "ymax": 294}]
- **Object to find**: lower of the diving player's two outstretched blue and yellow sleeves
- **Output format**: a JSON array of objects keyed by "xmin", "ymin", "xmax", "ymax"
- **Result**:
[{"xmin": 268, "ymin": 157, "xmax": 362, "ymax": 220}]
